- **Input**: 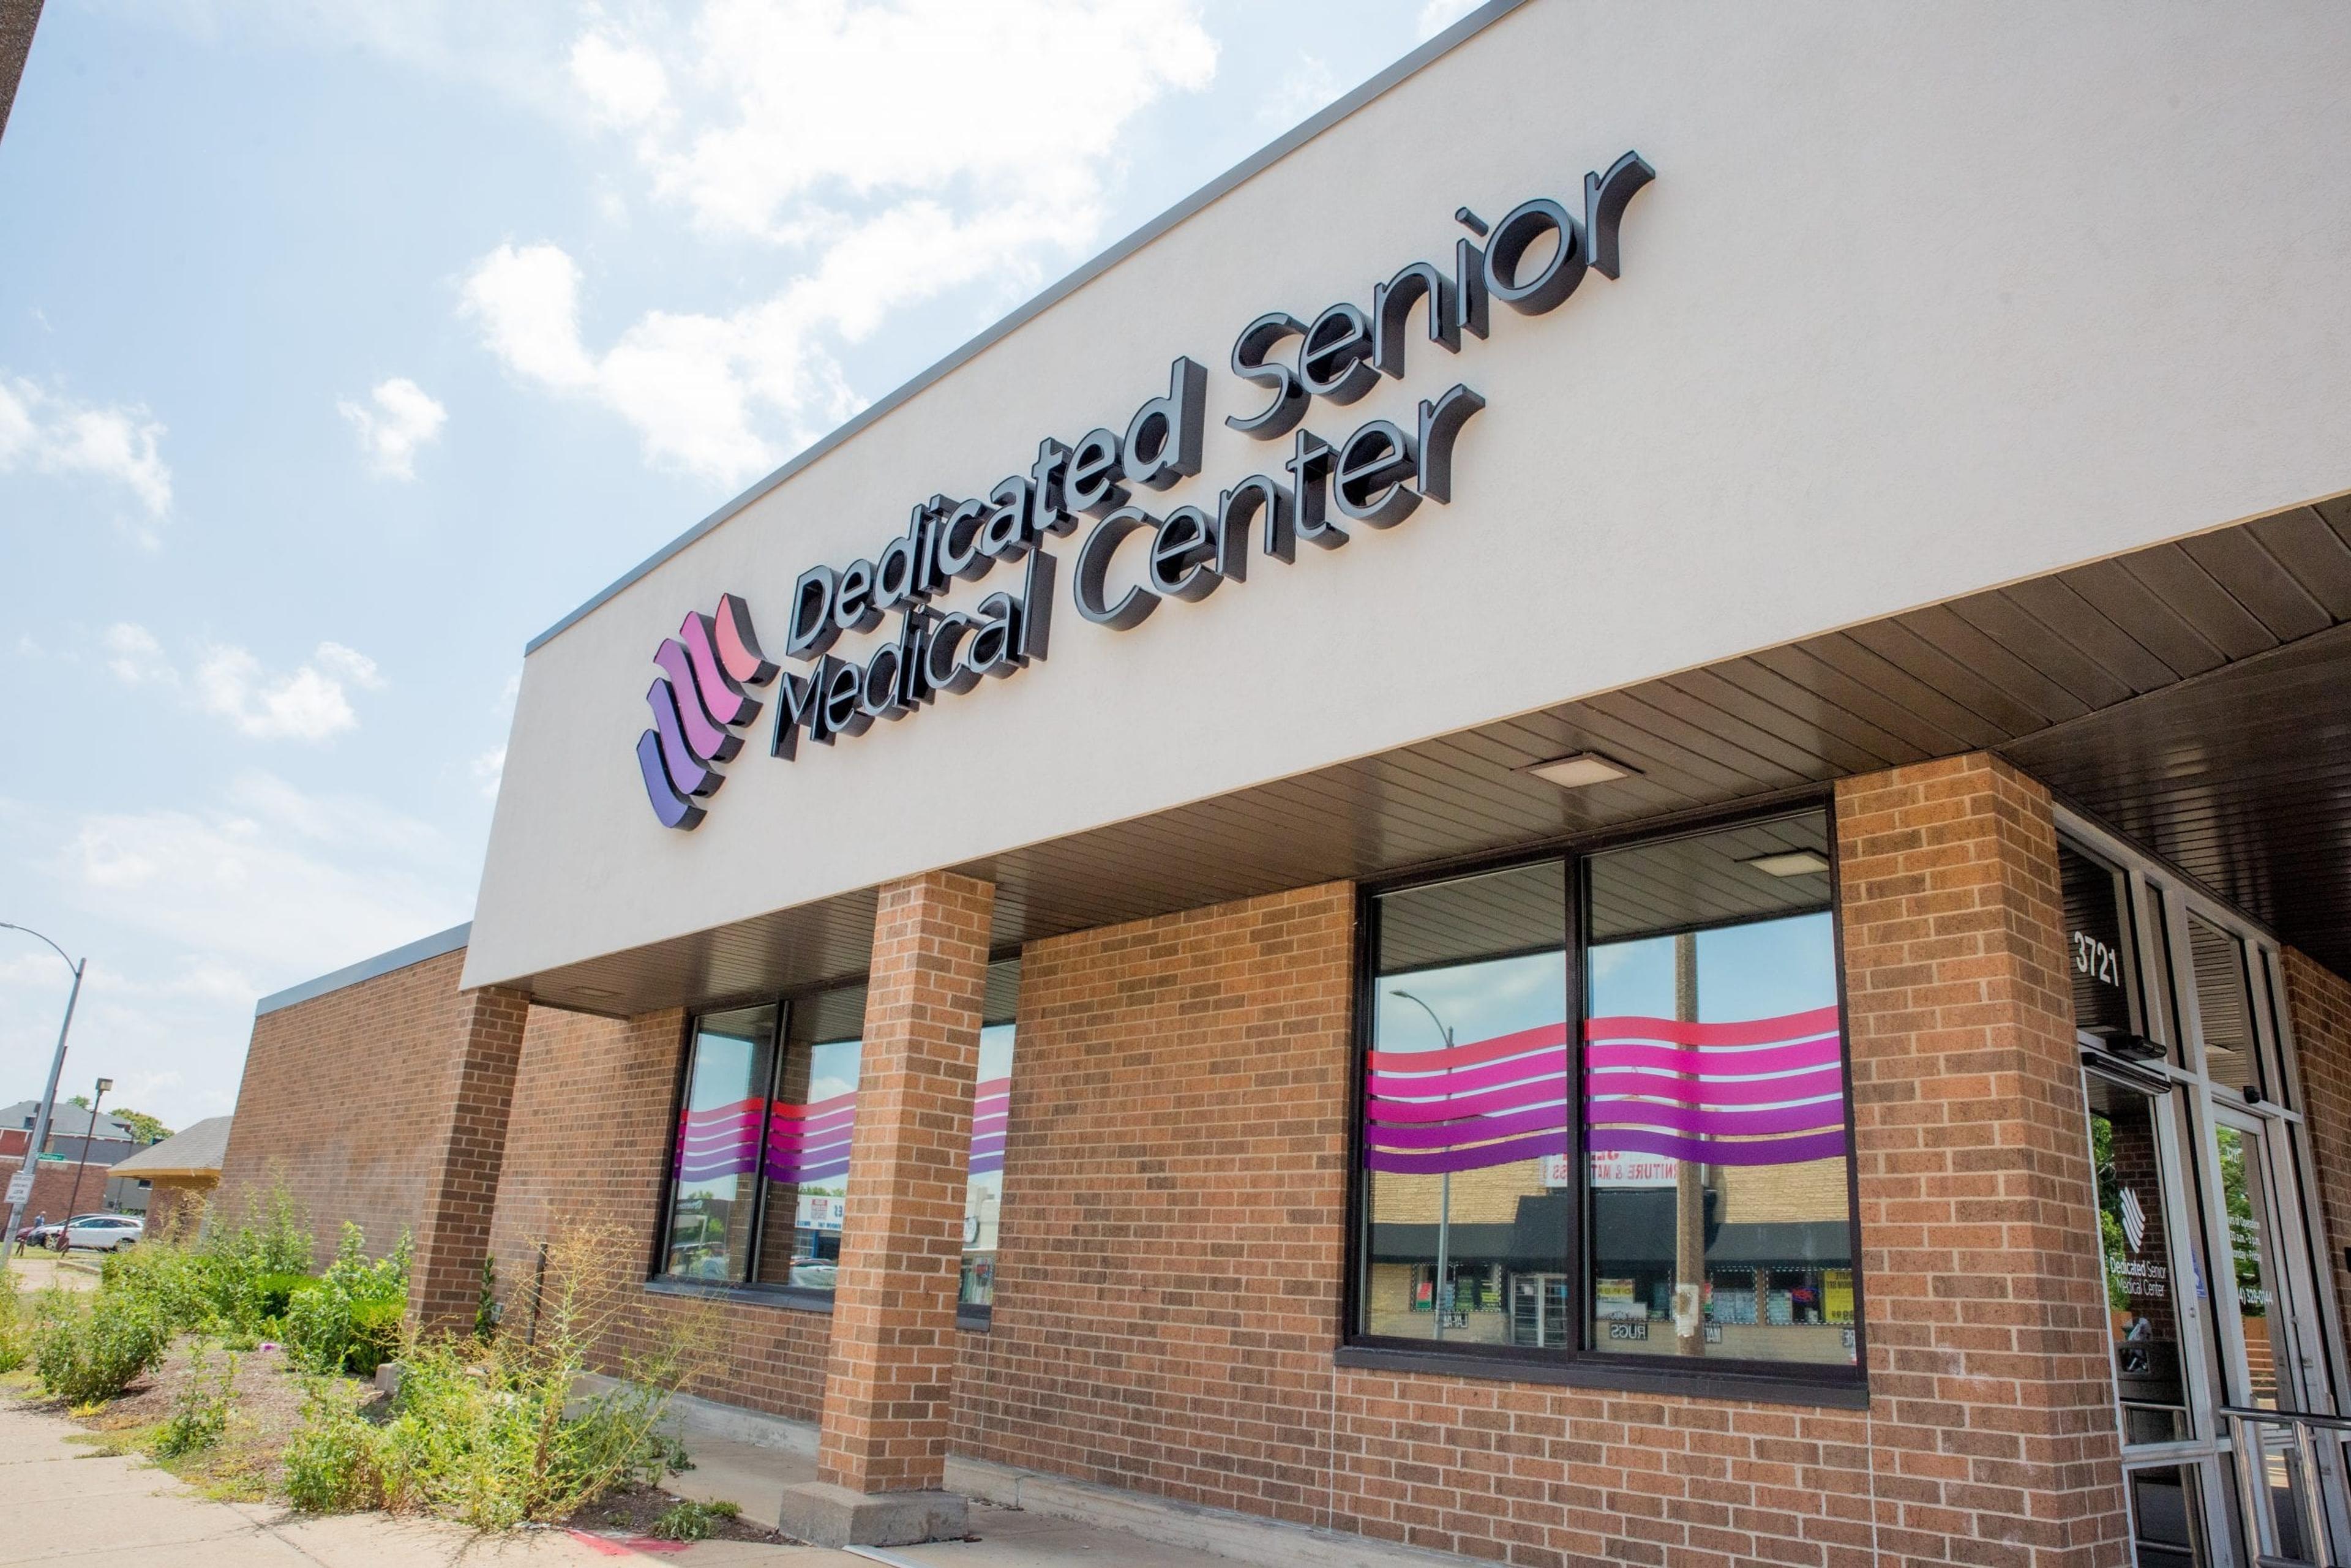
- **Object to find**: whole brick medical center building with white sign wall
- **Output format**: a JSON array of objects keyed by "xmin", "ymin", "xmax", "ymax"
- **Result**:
[{"xmin": 223, "ymin": 0, "xmax": 2351, "ymax": 1566}]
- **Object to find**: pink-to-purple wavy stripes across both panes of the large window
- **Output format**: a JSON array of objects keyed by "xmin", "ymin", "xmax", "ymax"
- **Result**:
[{"xmin": 1363, "ymin": 1006, "xmax": 1845, "ymax": 1176}]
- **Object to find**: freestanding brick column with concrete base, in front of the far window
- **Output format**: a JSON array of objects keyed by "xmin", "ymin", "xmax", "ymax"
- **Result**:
[{"xmin": 783, "ymin": 872, "xmax": 994, "ymax": 1547}]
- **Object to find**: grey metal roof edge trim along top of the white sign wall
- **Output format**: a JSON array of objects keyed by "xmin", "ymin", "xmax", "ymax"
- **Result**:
[{"xmin": 522, "ymin": 0, "xmax": 1526, "ymax": 658}]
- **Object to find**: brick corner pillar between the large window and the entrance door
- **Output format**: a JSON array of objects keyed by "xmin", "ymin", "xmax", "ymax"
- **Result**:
[{"xmin": 1836, "ymin": 755, "xmax": 2128, "ymax": 1568}]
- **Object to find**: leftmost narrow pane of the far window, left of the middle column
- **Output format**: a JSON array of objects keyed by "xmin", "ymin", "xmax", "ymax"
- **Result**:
[{"xmin": 663, "ymin": 1006, "xmax": 776, "ymax": 1281}]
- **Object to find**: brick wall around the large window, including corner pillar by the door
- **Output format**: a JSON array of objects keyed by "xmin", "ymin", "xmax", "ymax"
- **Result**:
[{"xmin": 959, "ymin": 757, "xmax": 2125, "ymax": 1568}]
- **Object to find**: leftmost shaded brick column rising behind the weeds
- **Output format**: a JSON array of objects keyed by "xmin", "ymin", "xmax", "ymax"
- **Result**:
[{"xmin": 409, "ymin": 985, "xmax": 531, "ymax": 1330}]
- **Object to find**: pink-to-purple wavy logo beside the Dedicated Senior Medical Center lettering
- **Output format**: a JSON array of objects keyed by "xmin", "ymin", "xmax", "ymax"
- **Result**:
[{"xmin": 637, "ymin": 593, "xmax": 776, "ymax": 832}]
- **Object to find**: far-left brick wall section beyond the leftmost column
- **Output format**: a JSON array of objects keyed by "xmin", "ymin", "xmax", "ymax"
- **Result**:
[{"xmin": 221, "ymin": 950, "xmax": 465, "ymax": 1262}]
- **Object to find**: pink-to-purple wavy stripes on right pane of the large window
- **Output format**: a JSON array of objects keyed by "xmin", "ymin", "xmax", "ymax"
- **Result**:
[{"xmin": 1584, "ymin": 1006, "xmax": 1845, "ymax": 1166}]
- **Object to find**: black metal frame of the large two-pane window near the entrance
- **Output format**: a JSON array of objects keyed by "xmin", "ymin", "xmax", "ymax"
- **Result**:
[{"xmin": 1333, "ymin": 790, "xmax": 1869, "ymax": 1411}]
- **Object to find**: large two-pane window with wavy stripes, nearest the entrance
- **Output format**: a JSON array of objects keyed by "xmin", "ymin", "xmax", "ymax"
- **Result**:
[{"xmin": 1354, "ymin": 811, "xmax": 1859, "ymax": 1368}]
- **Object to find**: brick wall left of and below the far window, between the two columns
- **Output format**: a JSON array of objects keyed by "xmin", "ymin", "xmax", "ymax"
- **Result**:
[{"xmin": 492, "ymin": 1006, "xmax": 832, "ymax": 1420}]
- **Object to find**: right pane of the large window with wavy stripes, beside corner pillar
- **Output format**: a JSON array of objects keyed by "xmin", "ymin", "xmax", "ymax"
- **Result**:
[{"xmin": 1584, "ymin": 813, "xmax": 1858, "ymax": 1366}]
